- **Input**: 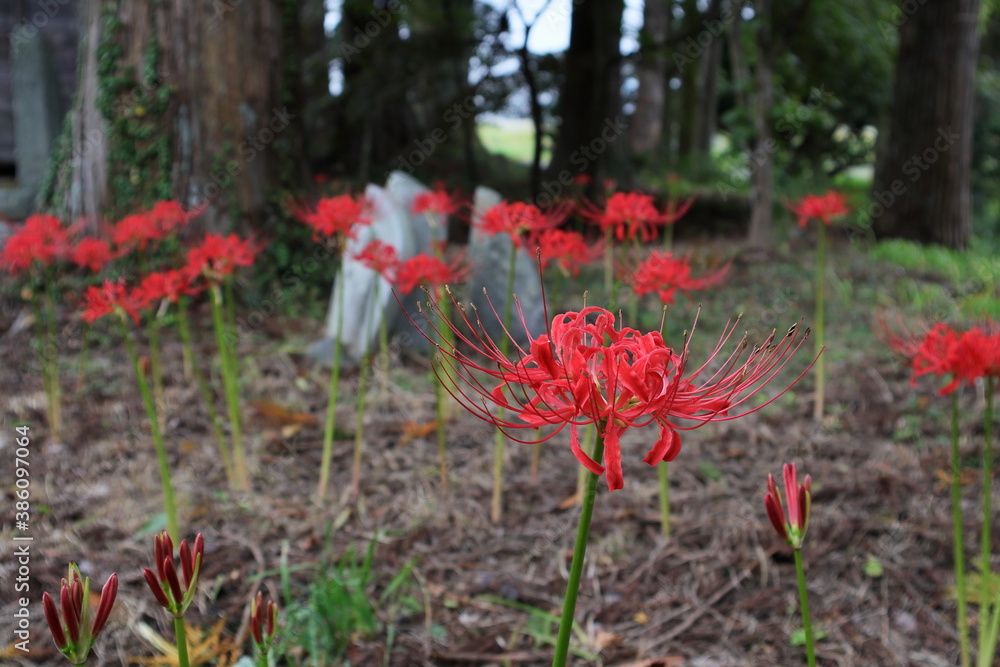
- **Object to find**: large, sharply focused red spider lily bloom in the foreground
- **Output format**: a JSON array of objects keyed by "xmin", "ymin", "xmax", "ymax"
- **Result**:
[{"xmin": 418, "ymin": 299, "xmax": 811, "ymax": 490}]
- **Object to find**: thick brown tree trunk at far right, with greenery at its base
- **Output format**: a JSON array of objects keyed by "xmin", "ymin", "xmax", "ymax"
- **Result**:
[{"xmin": 867, "ymin": 0, "xmax": 980, "ymax": 248}]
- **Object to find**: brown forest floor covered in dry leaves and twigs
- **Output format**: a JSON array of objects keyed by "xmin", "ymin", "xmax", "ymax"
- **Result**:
[{"xmin": 0, "ymin": 237, "xmax": 996, "ymax": 667}]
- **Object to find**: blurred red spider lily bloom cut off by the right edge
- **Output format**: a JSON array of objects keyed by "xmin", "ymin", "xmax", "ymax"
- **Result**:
[{"xmin": 908, "ymin": 323, "xmax": 1000, "ymax": 396}]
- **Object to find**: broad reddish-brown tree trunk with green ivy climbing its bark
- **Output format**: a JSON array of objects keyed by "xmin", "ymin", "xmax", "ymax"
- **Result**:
[{"xmin": 47, "ymin": 0, "xmax": 304, "ymax": 229}]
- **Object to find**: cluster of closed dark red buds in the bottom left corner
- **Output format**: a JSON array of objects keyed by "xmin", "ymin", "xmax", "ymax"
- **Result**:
[{"xmin": 42, "ymin": 563, "xmax": 118, "ymax": 665}]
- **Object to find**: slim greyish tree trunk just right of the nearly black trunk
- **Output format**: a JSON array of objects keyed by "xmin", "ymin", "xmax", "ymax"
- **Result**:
[{"xmin": 629, "ymin": 0, "xmax": 670, "ymax": 157}]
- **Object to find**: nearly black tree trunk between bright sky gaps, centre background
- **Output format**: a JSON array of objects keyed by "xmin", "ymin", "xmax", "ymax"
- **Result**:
[{"xmin": 549, "ymin": 0, "xmax": 627, "ymax": 186}]
